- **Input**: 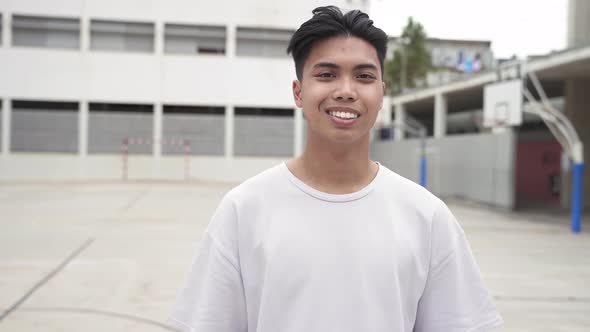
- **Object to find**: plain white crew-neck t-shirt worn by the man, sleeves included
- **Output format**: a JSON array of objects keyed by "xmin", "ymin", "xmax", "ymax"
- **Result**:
[{"xmin": 169, "ymin": 163, "xmax": 502, "ymax": 332}]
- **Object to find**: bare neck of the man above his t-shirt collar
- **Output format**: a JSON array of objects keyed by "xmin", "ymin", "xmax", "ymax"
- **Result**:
[{"xmin": 288, "ymin": 135, "xmax": 378, "ymax": 194}]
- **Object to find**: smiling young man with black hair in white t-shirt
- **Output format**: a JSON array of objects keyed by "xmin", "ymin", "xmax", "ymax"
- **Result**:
[{"xmin": 170, "ymin": 7, "xmax": 502, "ymax": 332}]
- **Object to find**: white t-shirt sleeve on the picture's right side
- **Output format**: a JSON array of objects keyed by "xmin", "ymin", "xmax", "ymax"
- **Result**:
[{"xmin": 414, "ymin": 202, "xmax": 503, "ymax": 332}]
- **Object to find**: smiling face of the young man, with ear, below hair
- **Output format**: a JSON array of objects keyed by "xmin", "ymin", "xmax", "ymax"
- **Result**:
[{"xmin": 293, "ymin": 36, "xmax": 384, "ymax": 145}]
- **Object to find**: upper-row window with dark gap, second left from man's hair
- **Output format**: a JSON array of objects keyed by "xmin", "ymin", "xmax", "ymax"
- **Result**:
[{"xmin": 164, "ymin": 24, "xmax": 226, "ymax": 54}]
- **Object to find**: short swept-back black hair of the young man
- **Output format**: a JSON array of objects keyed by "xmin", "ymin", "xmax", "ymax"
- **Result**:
[{"xmin": 287, "ymin": 6, "xmax": 387, "ymax": 80}]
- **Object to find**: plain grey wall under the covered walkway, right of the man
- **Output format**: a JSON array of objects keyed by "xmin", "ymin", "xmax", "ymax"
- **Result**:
[{"xmin": 370, "ymin": 131, "xmax": 516, "ymax": 210}]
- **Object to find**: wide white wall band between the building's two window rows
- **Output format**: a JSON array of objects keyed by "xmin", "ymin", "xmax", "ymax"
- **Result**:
[{"xmin": 0, "ymin": 48, "xmax": 295, "ymax": 107}]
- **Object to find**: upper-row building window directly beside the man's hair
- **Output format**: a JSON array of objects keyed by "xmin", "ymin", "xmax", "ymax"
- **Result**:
[{"xmin": 236, "ymin": 28, "xmax": 293, "ymax": 57}]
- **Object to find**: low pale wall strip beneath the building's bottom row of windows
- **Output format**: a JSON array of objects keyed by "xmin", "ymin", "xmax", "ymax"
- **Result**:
[{"xmin": 0, "ymin": 153, "xmax": 288, "ymax": 183}]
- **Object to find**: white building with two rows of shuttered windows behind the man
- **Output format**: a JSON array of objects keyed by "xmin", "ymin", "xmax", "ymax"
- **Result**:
[{"xmin": 0, "ymin": 0, "xmax": 368, "ymax": 180}]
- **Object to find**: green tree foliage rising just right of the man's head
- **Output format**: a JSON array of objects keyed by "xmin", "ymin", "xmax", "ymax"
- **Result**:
[{"xmin": 385, "ymin": 17, "xmax": 432, "ymax": 94}]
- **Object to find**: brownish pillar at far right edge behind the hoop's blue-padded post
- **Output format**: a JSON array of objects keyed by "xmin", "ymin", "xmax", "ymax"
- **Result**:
[{"xmin": 561, "ymin": 79, "xmax": 590, "ymax": 209}]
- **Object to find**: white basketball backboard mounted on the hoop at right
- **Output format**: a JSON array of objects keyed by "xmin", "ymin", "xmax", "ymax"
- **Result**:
[{"xmin": 483, "ymin": 80, "xmax": 522, "ymax": 127}]
